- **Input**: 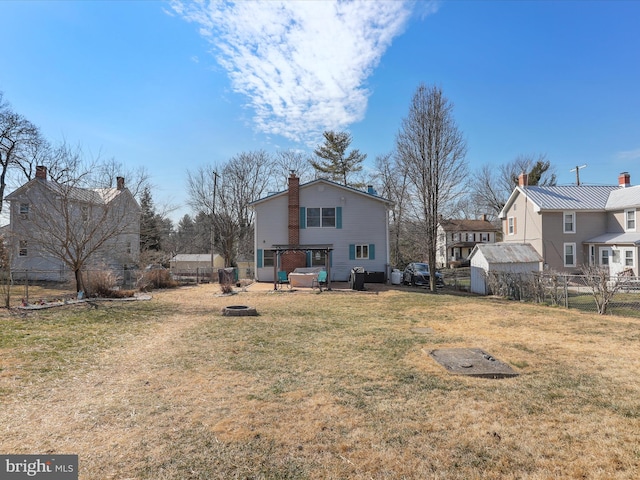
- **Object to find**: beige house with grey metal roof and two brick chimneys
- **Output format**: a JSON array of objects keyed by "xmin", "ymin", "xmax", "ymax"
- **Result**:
[{"xmin": 500, "ymin": 172, "xmax": 640, "ymax": 276}]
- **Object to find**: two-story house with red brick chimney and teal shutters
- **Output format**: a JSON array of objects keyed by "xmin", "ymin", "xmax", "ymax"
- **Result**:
[{"xmin": 251, "ymin": 173, "xmax": 392, "ymax": 282}]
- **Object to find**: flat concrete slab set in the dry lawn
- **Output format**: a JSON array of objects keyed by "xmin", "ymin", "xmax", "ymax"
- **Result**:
[{"xmin": 428, "ymin": 348, "xmax": 518, "ymax": 378}]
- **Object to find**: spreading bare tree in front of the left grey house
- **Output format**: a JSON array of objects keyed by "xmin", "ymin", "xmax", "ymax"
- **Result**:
[{"xmin": 11, "ymin": 154, "xmax": 140, "ymax": 291}]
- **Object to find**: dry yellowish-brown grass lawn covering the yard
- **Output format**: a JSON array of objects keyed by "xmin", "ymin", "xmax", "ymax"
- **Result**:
[{"xmin": 0, "ymin": 285, "xmax": 640, "ymax": 480}]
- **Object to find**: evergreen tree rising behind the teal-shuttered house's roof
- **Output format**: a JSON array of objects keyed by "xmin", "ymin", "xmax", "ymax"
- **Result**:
[{"xmin": 311, "ymin": 131, "xmax": 367, "ymax": 187}]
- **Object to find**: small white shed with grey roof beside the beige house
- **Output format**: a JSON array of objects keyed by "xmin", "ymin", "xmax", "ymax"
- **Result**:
[{"xmin": 469, "ymin": 243, "xmax": 543, "ymax": 295}]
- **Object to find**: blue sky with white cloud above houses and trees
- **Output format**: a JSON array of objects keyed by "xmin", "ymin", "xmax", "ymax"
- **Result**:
[{"xmin": 0, "ymin": 0, "xmax": 640, "ymax": 218}]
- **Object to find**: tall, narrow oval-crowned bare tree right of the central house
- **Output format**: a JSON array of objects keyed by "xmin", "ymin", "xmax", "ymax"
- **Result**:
[{"xmin": 396, "ymin": 84, "xmax": 467, "ymax": 292}]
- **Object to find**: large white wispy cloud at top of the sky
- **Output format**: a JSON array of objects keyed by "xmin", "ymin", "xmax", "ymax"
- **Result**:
[{"xmin": 172, "ymin": 0, "xmax": 414, "ymax": 141}]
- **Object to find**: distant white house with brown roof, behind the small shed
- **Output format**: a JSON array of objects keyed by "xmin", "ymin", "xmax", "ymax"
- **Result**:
[{"xmin": 436, "ymin": 215, "xmax": 500, "ymax": 268}]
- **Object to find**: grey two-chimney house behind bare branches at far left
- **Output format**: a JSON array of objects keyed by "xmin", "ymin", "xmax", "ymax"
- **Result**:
[{"xmin": 6, "ymin": 166, "xmax": 140, "ymax": 281}]
